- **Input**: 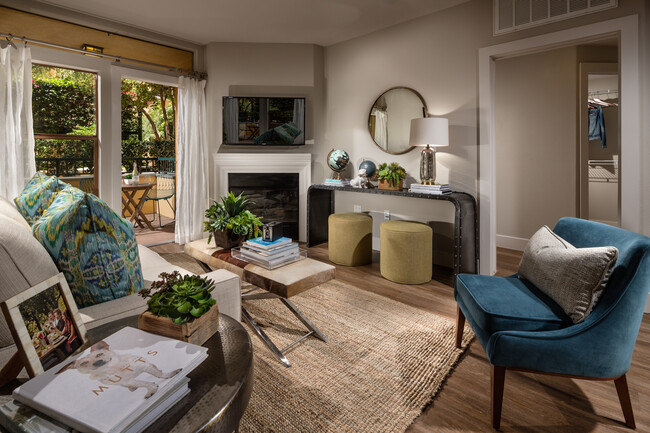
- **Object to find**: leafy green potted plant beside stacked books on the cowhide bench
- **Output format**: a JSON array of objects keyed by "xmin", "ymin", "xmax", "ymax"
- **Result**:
[{"xmin": 203, "ymin": 192, "xmax": 262, "ymax": 250}]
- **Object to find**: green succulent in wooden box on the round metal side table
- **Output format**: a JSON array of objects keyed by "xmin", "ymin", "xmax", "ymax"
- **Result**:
[{"xmin": 138, "ymin": 271, "xmax": 219, "ymax": 345}]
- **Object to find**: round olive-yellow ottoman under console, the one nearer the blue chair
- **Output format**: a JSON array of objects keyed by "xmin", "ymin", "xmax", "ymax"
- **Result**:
[{"xmin": 379, "ymin": 221, "xmax": 433, "ymax": 284}]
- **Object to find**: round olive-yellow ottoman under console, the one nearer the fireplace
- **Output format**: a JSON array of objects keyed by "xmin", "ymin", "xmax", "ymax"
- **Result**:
[{"xmin": 327, "ymin": 212, "xmax": 372, "ymax": 266}]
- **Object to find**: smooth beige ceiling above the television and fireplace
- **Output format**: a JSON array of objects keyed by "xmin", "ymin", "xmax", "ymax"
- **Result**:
[{"xmin": 35, "ymin": 0, "xmax": 469, "ymax": 46}]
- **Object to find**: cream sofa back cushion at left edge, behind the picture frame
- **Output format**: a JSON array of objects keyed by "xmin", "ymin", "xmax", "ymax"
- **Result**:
[{"xmin": 0, "ymin": 215, "xmax": 59, "ymax": 348}]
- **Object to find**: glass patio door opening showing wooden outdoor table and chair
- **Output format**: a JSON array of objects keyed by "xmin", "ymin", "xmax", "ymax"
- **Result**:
[{"xmin": 121, "ymin": 78, "xmax": 177, "ymax": 246}]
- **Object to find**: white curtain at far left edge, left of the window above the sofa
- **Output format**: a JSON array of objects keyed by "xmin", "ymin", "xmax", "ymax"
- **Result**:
[{"xmin": 0, "ymin": 45, "xmax": 36, "ymax": 199}]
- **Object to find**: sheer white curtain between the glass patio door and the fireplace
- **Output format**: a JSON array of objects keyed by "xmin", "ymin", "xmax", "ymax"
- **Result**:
[{"xmin": 175, "ymin": 77, "xmax": 209, "ymax": 245}]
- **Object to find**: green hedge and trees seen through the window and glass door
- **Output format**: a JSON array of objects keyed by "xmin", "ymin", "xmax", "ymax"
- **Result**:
[{"xmin": 32, "ymin": 65, "xmax": 176, "ymax": 174}]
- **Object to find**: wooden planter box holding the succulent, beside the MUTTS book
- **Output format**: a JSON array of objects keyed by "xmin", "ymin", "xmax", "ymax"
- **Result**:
[{"xmin": 138, "ymin": 304, "xmax": 219, "ymax": 346}]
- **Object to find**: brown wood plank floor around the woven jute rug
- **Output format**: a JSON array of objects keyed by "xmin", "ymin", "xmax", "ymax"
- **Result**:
[{"xmin": 154, "ymin": 244, "xmax": 650, "ymax": 433}]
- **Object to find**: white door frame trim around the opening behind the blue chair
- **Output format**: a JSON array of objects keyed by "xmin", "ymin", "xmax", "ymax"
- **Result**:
[{"xmin": 478, "ymin": 15, "xmax": 650, "ymax": 276}]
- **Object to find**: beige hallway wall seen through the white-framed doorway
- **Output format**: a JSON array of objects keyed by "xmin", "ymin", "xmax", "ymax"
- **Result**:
[{"xmin": 495, "ymin": 47, "xmax": 578, "ymax": 250}]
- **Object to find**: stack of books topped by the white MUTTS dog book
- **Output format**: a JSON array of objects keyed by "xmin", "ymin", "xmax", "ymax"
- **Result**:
[{"xmin": 13, "ymin": 327, "xmax": 208, "ymax": 433}]
